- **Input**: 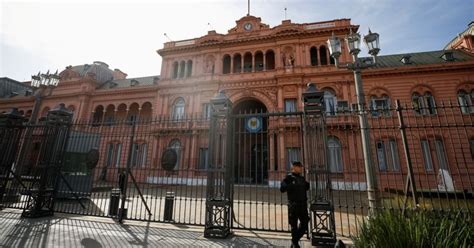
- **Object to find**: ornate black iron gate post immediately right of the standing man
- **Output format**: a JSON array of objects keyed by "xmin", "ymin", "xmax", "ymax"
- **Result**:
[{"xmin": 303, "ymin": 83, "xmax": 336, "ymax": 247}]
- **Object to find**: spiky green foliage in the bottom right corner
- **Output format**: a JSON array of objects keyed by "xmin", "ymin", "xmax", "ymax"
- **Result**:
[{"xmin": 353, "ymin": 211, "xmax": 474, "ymax": 248}]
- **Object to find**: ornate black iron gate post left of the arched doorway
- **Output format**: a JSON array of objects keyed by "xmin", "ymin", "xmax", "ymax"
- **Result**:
[{"xmin": 204, "ymin": 91, "xmax": 234, "ymax": 238}]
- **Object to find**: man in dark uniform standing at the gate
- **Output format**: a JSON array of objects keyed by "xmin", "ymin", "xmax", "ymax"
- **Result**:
[{"xmin": 280, "ymin": 161, "xmax": 309, "ymax": 247}]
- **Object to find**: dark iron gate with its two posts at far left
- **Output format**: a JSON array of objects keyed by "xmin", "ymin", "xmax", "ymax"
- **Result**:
[{"xmin": 0, "ymin": 104, "xmax": 78, "ymax": 218}]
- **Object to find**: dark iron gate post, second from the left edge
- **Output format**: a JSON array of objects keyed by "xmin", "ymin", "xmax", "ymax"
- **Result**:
[{"xmin": 21, "ymin": 103, "xmax": 72, "ymax": 218}]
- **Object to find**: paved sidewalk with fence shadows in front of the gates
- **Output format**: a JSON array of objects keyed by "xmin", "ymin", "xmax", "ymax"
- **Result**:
[{"xmin": 0, "ymin": 209, "xmax": 318, "ymax": 248}]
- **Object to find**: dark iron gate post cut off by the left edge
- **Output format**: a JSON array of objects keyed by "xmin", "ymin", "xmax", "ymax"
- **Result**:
[{"xmin": 0, "ymin": 108, "xmax": 25, "ymax": 209}]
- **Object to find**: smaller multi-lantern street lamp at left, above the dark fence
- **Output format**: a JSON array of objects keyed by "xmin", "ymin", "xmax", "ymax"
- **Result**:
[{"xmin": 29, "ymin": 70, "xmax": 60, "ymax": 124}]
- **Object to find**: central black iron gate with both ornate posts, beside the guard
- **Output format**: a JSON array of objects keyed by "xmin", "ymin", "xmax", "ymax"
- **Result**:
[{"xmin": 205, "ymin": 85, "xmax": 335, "ymax": 244}]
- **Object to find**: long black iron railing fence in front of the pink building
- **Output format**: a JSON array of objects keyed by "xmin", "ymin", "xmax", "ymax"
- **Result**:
[{"xmin": 0, "ymin": 98, "xmax": 474, "ymax": 236}]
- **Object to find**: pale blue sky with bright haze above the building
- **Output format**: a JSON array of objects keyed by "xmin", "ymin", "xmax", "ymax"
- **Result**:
[{"xmin": 0, "ymin": 0, "xmax": 474, "ymax": 81}]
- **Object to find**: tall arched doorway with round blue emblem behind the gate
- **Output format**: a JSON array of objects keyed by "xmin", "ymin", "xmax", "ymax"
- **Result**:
[{"xmin": 232, "ymin": 98, "xmax": 268, "ymax": 184}]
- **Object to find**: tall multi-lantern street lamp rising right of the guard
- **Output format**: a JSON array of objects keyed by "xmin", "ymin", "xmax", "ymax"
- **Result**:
[{"xmin": 327, "ymin": 29, "xmax": 380, "ymax": 211}]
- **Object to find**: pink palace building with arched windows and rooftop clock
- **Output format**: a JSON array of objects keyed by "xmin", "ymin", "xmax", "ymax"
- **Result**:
[{"xmin": 0, "ymin": 15, "xmax": 474, "ymax": 190}]
